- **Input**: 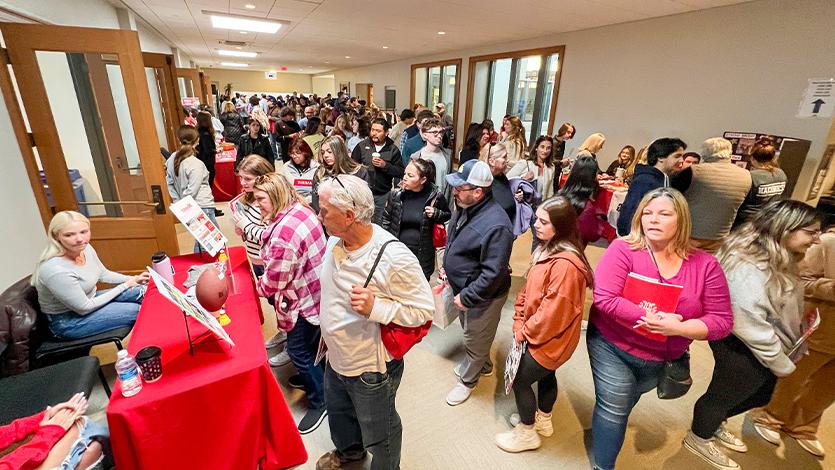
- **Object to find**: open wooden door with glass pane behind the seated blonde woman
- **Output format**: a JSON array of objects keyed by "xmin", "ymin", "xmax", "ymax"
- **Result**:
[{"xmin": 0, "ymin": 23, "xmax": 179, "ymax": 272}]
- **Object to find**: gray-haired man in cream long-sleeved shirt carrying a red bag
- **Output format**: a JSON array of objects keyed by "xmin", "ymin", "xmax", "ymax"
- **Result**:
[{"xmin": 316, "ymin": 175, "xmax": 434, "ymax": 470}]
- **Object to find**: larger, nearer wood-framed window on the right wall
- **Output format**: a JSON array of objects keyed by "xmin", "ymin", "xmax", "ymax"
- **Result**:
[{"xmin": 467, "ymin": 46, "xmax": 564, "ymax": 142}]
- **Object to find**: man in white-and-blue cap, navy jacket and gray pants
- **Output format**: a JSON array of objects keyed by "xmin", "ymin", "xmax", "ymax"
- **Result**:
[{"xmin": 444, "ymin": 160, "xmax": 513, "ymax": 406}]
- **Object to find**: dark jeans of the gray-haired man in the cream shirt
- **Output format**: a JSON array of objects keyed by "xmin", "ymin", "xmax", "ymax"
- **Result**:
[{"xmin": 325, "ymin": 360, "xmax": 403, "ymax": 470}]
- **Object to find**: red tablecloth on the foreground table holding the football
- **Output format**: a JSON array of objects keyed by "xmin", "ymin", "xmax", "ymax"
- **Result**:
[{"xmin": 107, "ymin": 247, "xmax": 307, "ymax": 470}]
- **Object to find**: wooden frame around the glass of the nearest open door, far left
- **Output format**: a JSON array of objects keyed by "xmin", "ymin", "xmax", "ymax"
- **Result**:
[{"xmin": 0, "ymin": 23, "xmax": 179, "ymax": 253}]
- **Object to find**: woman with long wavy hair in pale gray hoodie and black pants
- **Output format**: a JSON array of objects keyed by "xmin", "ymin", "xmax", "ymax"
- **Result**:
[{"xmin": 684, "ymin": 200, "xmax": 821, "ymax": 469}]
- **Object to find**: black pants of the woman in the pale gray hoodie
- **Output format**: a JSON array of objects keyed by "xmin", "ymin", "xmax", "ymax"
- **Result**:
[{"xmin": 693, "ymin": 335, "xmax": 777, "ymax": 439}]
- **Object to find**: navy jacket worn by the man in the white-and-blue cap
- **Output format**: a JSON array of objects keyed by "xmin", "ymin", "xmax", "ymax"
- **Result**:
[{"xmin": 444, "ymin": 195, "xmax": 513, "ymax": 307}]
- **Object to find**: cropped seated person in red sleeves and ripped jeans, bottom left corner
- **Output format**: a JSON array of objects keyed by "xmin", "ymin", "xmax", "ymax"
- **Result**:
[{"xmin": 0, "ymin": 393, "xmax": 110, "ymax": 470}]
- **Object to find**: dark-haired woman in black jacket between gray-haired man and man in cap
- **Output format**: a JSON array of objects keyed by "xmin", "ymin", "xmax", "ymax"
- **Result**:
[{"xmin": 382, "ymin": 158, "xmax": 452, "ymax": 280}]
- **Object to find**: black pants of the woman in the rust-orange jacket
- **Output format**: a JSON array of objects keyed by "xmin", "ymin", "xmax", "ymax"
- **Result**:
[{"xmin": 513, "ymin": 351, "xmax": 557, "ymax": 425}]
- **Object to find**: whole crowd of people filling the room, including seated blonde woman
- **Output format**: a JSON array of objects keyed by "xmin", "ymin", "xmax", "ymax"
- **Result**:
[{"xmin": 16, "ymin": 88, "xmax": 835, "ymax": 470}]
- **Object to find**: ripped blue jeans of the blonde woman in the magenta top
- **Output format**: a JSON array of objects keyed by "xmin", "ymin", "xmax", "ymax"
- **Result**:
[{"xmin": 586, "ymin": 324, "xmax": 664, "ymax": 470}]
